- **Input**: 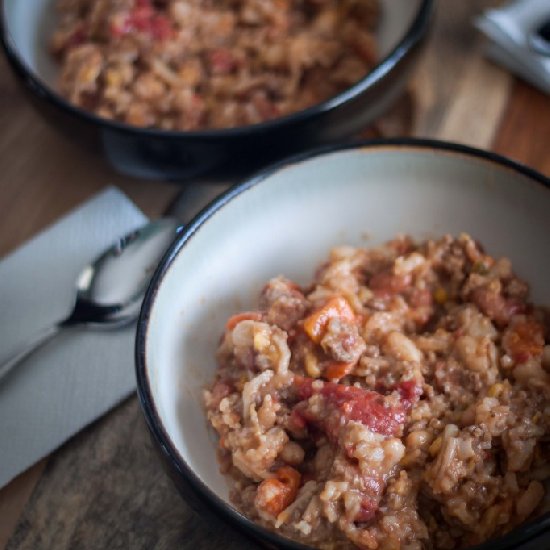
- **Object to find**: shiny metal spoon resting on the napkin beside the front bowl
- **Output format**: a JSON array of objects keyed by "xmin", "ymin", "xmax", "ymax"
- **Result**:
[{"xmin": 0, "ymin": 218, "xmax": 180, "ymax": 380}]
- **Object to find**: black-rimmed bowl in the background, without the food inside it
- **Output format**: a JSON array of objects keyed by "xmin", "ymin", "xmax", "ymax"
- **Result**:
[{"xmin": 0, "ymin": 0, "xmax": 433, "ymax": 181}]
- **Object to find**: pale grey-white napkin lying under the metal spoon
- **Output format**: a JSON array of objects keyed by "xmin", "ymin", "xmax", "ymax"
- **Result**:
[{"xmin": 0, "ymin": 188, "xmax": 147, "ymax": 487}]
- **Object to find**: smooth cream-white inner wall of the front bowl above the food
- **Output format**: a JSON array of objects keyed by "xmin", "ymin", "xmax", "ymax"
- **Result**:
[{"xmin": 145, "ymin": 145, "xmax": 550, "ymax": 508}]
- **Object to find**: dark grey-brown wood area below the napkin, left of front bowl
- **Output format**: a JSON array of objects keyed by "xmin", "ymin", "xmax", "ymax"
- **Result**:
[{"xmin": 8, "ymin": 398, "xmax": 253, "ymax": 550}]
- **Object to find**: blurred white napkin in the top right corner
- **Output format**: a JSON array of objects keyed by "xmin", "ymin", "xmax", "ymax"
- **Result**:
[{"xmin": 474, "ymin": 0, "xmax": 550, "ymax": 93}]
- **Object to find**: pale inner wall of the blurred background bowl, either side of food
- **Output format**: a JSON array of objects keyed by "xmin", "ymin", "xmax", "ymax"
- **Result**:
[{"xmin": 3, "ymin": 0, "xmax": 422, "ymax": 92}]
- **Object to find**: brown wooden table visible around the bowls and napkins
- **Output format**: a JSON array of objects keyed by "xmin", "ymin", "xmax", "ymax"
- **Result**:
[{"xmin": 0, "ymin": 0, "xmax": 550, "ymax": 550}]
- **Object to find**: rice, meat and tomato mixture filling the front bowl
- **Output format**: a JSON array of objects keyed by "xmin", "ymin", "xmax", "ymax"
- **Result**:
[{"xmin": 204, "ymin": 235, "xmax": 550, "ymax": 550}]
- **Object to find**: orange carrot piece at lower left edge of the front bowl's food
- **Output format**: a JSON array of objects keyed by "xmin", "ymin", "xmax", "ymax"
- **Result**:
[{"xmin": 256, "ymin": 466, "xmax": 302, "ymax": 517}]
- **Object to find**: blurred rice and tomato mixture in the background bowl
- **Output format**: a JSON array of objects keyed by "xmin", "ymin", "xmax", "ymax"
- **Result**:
[{"xmin": 51, "ymin": 0, "xmax": 378, "ymax": 130}]
